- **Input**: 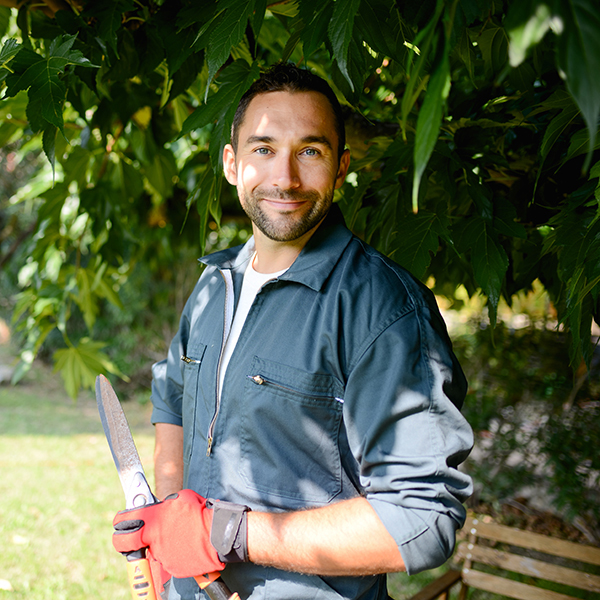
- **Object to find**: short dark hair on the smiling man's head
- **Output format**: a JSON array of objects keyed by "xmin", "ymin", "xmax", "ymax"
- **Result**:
[{"xmin": 231, "ymin": 63, "xmax": 346, "ymax": 161}]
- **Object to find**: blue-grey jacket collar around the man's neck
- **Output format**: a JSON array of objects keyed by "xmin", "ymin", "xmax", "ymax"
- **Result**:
[{"xmin": 199, "ymin": 204, "xmax": 352, "ymax": 291}]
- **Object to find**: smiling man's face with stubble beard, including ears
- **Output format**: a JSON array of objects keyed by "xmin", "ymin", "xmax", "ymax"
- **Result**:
[{"xmin": 223, "ymin": 92, "xmax": 349, "ymax": 242}]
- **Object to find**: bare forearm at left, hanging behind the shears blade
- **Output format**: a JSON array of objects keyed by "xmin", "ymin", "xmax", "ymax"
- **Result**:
[{"xmin": 154, "ymin": 423, "xmax": 183, "ymax": 500}]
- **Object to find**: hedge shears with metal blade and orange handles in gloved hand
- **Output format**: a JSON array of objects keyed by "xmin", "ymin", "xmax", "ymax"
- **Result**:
[{"xmin": 96, "ymin": 375, "xmax": 240, "ymax": 600}]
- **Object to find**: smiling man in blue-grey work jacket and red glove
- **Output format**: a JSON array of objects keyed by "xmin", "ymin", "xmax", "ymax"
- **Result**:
[{"xmin": 114, "ymin": 65, "xmax": 472, "ymax": 600}]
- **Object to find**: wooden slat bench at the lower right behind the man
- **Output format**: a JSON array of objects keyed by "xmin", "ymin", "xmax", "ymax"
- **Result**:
[{"xmin": 410, "ymin": 517, "xmax": 600, "ymax": 600}]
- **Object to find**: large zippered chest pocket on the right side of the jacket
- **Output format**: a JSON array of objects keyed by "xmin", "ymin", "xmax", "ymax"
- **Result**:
[{"xmin": 240, "ymin": 357, "xmax": 343, "ymax": 508}]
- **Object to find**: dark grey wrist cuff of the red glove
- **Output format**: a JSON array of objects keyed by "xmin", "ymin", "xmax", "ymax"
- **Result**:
[{"xmin": 206, "ymin": 500, "xmax": 250, "ymax": 563}]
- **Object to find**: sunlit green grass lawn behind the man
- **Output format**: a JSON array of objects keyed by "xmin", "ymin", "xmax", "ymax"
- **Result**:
[{"xmin": 0, "ymin": 346, "xmax": 450, "ymax": 600}]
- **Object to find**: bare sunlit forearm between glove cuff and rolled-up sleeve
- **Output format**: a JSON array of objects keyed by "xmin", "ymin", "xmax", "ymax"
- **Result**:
[{"xmin": 248, "ymin": 498, "xmax": 405, "ymax": 576}]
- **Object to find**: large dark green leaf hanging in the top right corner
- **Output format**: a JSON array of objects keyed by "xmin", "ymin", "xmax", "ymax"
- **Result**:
[{"xmin": 557, "ymin": 0, "xmax": 600, "ymax": 171}]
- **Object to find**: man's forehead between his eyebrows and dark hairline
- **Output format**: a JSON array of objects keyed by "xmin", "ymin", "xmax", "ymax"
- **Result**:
[{"xmin": 239, "ymin": 92, "xmax": 338, "ymax": 146}]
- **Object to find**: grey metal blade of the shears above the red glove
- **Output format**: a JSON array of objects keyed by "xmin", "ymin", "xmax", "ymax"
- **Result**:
[{"xmin": 96, "ymin": 375, "xmax": 155, "ymax": 508}]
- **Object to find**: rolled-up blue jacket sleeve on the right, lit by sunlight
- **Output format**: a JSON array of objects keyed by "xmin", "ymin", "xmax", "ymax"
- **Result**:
[{"xmin": 344, "ymin": 306, "xmax": 473, "ymax": 574}]
